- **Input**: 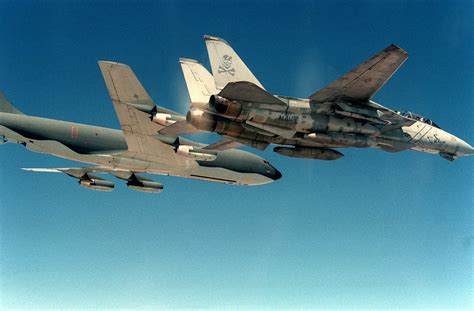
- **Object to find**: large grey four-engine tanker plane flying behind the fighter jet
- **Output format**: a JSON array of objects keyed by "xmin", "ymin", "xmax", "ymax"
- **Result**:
[{"xmin": 0, "ymin": 61, "xmax": 281, "ymax": 192}]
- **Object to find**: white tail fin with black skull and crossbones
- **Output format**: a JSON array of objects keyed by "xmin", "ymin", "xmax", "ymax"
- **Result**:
[{"xmin": 204, "ymin": 35, "xmax": 265, "ymax": 89}]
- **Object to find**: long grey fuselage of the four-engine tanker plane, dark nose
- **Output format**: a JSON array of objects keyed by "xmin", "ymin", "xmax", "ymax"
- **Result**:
[{"xmin": 0, "ymin": 112, "xmax": 281, "ymax": 184}]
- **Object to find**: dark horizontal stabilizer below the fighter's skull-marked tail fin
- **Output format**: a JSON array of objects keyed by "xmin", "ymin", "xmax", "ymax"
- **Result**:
[{"xmin": 219, "ymin": 81, "xmax": 287, "ymax": 107}]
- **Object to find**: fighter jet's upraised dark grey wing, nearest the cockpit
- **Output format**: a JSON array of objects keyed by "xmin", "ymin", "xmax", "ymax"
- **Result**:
[{"xmin": 309, "ymin": 44, "xmax": 408, "ymax": 102}]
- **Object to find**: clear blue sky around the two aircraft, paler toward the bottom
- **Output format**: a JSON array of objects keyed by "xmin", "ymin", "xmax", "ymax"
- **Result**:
[{"xmin": 0, "ymin": 1, "xmax": 474, "ymax": 310}]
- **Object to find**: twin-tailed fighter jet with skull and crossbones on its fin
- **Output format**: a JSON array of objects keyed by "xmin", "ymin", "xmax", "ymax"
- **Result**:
[{"xmin": 163, "ymin": 36, "xmax": 474, "ymax": 161}]
